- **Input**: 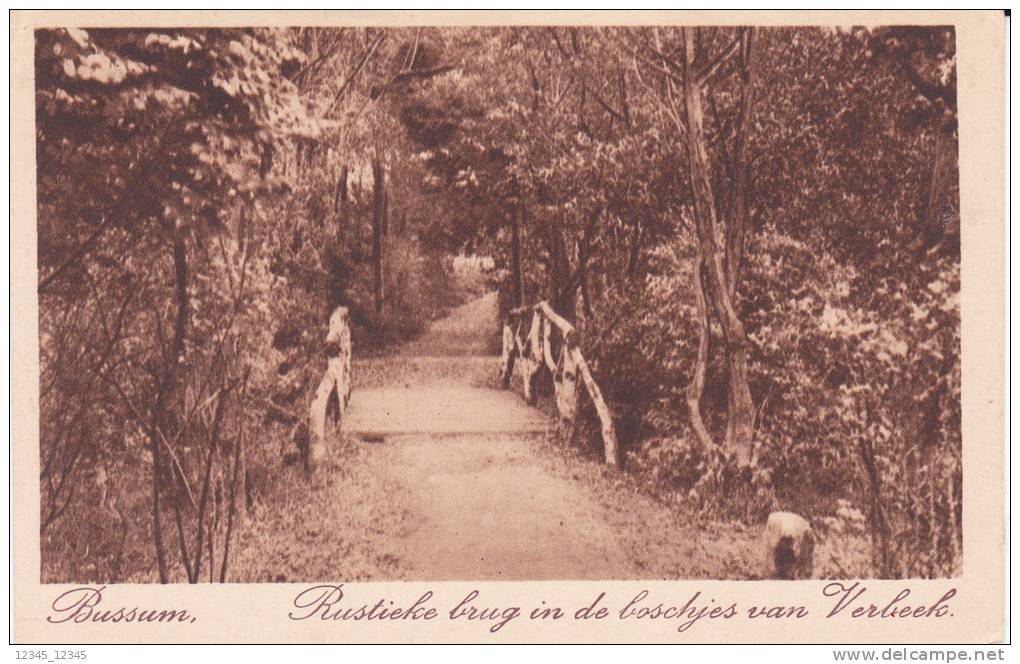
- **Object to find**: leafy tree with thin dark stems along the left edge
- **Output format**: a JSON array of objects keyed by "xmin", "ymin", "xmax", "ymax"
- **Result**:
[{"xmin": 36, "ymin": 30, "xmax": 320, "ymax": 582}]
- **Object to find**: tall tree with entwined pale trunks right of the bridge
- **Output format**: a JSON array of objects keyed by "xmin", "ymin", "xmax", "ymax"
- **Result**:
[{"xmin": 625, "ymin": 29, "xmax": 756, "ymax": 464}]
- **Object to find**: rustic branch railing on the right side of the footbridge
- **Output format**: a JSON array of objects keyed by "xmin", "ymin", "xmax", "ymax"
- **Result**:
[{"xmin": 500, "ymin": 302, "xmax": 620, "ymax": 467}]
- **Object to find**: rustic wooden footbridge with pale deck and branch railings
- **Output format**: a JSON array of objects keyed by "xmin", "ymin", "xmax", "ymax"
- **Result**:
[{"xmin": 308, "ymin": 302, "xmax": 620, "ymax": 467}]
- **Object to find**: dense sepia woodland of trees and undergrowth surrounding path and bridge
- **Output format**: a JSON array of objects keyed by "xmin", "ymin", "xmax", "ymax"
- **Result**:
[{"xmin": 36, "ymin": 27, "xmax": 963, "ymax": 581}]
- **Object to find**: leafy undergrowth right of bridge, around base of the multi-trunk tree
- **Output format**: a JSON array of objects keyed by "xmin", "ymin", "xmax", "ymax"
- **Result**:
[{"xmin": 585, "ymin": 229, "xmax": 961, "ymax": 576}]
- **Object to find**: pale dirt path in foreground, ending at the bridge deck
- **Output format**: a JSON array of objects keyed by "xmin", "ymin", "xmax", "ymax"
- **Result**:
[{"xmin": 348, "ymin": 435, "xmax": 632, "ymax": 580}]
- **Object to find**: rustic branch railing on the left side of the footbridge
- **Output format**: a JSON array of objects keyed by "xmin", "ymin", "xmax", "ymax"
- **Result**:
[{"xmin": 307, "ymin": 307, "xmax": 352, "ymax": 468}]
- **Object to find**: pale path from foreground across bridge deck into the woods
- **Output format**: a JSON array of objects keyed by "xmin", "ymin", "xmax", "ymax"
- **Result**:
[{"xmin": 345, "ymin": 294, "xmax": 627, "ymax": 579}]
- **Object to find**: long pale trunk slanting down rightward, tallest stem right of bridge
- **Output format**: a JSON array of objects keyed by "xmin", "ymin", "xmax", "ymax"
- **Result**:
[{"xmin": 683, "ymin": 29, "xmax": 754, "ymax": 465}]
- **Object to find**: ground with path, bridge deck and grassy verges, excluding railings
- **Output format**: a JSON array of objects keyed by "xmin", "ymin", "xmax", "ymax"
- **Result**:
[{"xmin": 231, "ymin": 295, "xmax": 864, "ymax": 582}]
